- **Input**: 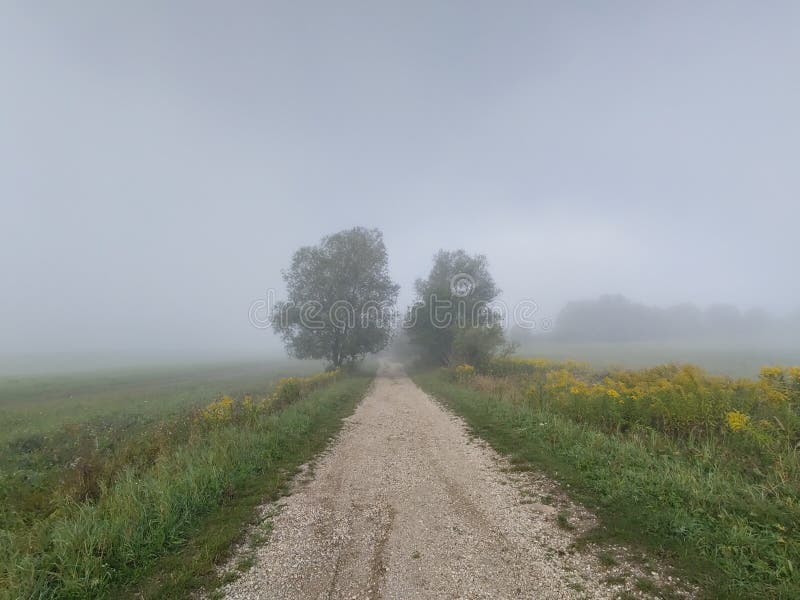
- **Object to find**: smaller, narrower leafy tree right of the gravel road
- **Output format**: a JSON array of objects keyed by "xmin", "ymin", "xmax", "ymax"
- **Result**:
[{"xmin": 405, "ymin": 250, "xmax": 504, "ymax": 365}]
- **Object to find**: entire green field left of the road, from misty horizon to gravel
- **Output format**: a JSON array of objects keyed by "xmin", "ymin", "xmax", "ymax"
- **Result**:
[{"xmin": 0, "ymin": 363, "xmax": 370, "ymax": 598}]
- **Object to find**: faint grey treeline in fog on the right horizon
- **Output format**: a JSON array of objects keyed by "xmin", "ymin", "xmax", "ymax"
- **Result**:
[{"xmin": 532, "ymin": 295, "xmax": 800, "ymax": 343}]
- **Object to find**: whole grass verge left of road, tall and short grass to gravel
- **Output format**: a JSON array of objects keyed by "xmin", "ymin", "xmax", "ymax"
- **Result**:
[{"xmin": 0, "ymin": 376, "xmax": 370, "ymax": 598}]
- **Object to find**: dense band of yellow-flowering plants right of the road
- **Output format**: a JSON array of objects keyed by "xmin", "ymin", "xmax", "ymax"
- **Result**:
[{"xmin": 478, "ymin": 358, "xmax": 800, "ymax": 452}]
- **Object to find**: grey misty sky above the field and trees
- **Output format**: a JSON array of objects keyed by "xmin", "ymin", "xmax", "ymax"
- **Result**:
[{"xmin": 0, "ymin": 1, "xmax": 800, "ymax": 353}]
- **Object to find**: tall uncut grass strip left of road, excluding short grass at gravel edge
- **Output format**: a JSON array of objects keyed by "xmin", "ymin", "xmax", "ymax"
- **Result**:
[{"xmin": 0, "ymin": 377, "xmax": 369, "ymax": 598}]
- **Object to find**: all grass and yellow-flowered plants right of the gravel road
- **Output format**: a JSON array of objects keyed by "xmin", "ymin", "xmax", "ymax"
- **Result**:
[{"xmin": 416, "ymin": 358, "xmax": 800, "ymax": 598}]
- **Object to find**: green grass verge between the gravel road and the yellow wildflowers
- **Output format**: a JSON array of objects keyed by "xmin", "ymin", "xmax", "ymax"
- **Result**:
[{"xmin": 415, "ymin": 371, "xmax": 800, "ymax": 599}]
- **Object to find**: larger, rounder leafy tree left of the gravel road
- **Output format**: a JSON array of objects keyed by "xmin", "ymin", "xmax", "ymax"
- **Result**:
[{"xmin": 272, "ymin": 227, "xmax": 400, "ymax": 367}]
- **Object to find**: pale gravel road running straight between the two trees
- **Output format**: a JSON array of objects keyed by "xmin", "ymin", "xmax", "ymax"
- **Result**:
[{"xmin": 223, "ymin": 367, "xmax": 684, "ymax": 600}]
